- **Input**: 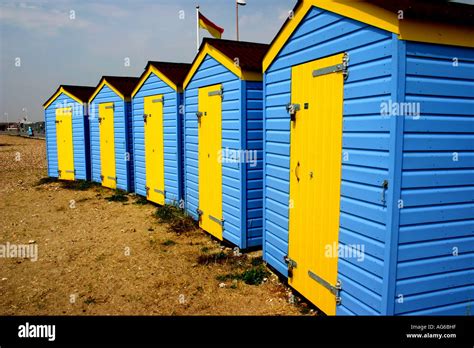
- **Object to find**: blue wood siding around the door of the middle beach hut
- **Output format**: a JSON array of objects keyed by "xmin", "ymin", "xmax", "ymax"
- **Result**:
[{"xmin": 132, "ymin": 73, "xmax": 183, "ymax": 204}]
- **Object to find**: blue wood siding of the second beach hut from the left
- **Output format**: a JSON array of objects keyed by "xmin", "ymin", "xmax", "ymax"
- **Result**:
[{"xmin": 89, "ymin": 85, "xmax": 134, "ymax": 192}]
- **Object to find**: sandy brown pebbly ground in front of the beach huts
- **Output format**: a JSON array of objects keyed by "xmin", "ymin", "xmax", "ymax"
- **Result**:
[{"xmin": 0, "ymin": 135, "xmax": 315, "ymax": 315}]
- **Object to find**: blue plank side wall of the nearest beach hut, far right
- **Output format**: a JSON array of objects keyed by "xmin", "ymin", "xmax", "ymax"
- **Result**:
[{"xmin": 395, "ymin": 42, "xmax": 474, "ymax": 315}]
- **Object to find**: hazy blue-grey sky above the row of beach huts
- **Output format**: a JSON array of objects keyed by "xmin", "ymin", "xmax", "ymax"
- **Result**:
[{"xmin": 0, "ymin": 0, "xmax": 296, "ymax": 122}]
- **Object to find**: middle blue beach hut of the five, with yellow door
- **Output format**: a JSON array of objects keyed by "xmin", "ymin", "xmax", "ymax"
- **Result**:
[{"xmin": 132, "ymin": 61, "xmax": 191, "ymax": 204}]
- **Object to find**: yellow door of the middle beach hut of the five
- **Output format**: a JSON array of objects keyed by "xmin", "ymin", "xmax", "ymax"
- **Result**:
[{"xmin": 143, "ymin": 95, "xmax": 165, "ymax": 205}]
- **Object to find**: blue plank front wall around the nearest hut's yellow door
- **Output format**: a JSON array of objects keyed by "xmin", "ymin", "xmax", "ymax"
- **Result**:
[{"xmin": 264, "ymin": 7, "xmax": 393, "ymax": 315}]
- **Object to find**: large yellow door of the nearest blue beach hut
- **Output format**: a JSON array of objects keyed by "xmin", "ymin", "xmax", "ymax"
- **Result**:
[{"xmin": 287, "ymin": 54, "xmax": 344, "ymax": 315}]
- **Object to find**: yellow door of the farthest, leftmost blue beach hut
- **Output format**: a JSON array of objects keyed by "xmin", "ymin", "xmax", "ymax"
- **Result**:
[{"xmin": 56, "ymin": 107, "xmax": 74, "ymax": 180}]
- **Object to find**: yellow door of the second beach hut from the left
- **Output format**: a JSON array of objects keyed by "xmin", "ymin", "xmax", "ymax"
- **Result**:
[{"xmin": 99, "ymin": 103, "xmax": 117, "ymax": 189}]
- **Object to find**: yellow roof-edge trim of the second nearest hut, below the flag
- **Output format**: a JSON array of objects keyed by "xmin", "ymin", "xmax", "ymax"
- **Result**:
[{"xmin": 183, "ymin": 43, "xmax": 263, "ymax": 89}]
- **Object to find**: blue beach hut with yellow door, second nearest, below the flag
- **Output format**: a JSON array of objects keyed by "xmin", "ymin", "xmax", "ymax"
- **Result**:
[{"xmin": 184, "ymin": 39, "xmax": 268, "ymax": 249}]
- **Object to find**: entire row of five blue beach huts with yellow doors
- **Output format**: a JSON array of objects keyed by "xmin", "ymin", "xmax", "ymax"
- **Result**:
[{"xmin": 44, "ymin": 0, "xmax": 474, "ymax": 315}]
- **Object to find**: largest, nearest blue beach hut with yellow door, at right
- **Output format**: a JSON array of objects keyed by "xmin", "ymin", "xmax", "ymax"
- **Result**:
[{"xmin": 262, "ymin": 0, "xmax": 474, "ymax": 315}]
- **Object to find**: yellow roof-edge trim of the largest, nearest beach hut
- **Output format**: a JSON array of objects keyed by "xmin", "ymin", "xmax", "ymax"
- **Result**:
[{"xmin": 263, "ymin": 0, "xmax": 474, "ymax": 72}]
